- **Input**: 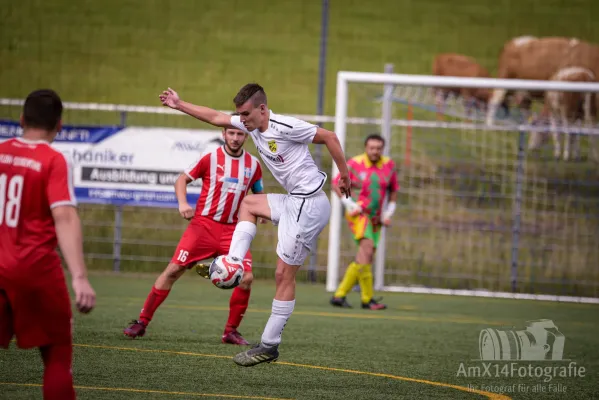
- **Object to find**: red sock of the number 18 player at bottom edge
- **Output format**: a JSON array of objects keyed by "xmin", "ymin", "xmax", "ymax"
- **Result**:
[{"xmin": 40, "ymin": 343, "xmax": 75, "ymax": 400}]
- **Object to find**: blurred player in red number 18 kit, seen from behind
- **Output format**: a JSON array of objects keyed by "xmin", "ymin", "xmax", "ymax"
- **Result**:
[{"xmin": 0, "ymin": 90, "xmax": 96, "ymax": 400}]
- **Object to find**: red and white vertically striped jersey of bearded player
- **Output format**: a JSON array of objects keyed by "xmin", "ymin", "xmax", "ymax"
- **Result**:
[{"xmin": 185, "ymin": 146, "xmax": 262, "ymax": 224}]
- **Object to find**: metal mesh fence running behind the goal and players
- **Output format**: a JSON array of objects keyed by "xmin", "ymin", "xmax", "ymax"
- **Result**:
[{"xmin": 2, "ymin": 87, "xmax": 599, "ymax": 296}]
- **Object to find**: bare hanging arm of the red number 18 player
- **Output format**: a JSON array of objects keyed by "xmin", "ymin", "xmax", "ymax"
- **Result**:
[{"xmin": 52, "ymin": 205, "xmax": 96, "ymax": 313}]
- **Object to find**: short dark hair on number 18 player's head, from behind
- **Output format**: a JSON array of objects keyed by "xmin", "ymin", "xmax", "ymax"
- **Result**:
[{"xmin": 23, "ymin": 89, "xmax": 62, "ymax": 131}]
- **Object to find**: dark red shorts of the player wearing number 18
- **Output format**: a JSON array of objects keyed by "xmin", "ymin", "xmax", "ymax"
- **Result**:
[{"xmin": 0, "ymin": 263, "xmax": 72, "ymax": 349}]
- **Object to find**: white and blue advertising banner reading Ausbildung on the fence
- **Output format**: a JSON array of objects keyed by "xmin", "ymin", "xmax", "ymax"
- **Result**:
[{"xmin": 0, "ymin": 121, "xmax": 223, "ymax": 207}]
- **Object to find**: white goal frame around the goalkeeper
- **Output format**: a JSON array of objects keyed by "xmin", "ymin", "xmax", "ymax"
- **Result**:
[{"xmin": 326, "ymin": 71, "xmax": 599, "ymax": 303}]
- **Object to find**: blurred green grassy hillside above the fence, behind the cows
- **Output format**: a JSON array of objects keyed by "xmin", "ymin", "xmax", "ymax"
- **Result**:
[{"xmin": 0, "ymin": 0, "xmax": 599, "ymax": 114}]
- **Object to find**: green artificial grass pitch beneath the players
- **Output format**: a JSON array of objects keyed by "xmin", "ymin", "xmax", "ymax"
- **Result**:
[{"xmin": 0, "ymin": 273, "xmax": 599, "ymax": 400}]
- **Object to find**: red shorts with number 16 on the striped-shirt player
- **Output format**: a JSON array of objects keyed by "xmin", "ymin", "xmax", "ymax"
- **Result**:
[{"xmin": 171, "ymin": 217, "xmax": 252, "ymax": 272}]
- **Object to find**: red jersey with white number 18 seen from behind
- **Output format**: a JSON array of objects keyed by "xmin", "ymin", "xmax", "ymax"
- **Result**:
[{"xmin": 0, "ymin": 138, "xmax": 77, "ymax": 272}]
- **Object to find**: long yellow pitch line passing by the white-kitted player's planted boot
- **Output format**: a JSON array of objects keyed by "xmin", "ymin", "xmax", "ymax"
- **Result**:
[{"xmin": 73, "ymin": 343, "xmax": 511, "ymax": 400}]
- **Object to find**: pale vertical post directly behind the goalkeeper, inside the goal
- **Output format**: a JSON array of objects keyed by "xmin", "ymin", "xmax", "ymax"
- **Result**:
[{"xmin": 374, "ymin": 64, "xmax": 394, "ymax": 290}]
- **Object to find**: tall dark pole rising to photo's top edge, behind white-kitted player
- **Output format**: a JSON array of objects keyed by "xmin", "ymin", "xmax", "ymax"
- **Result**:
[{"xmin": 308, "ymin": 0, "xmax": 332, "ymax": 283}]
